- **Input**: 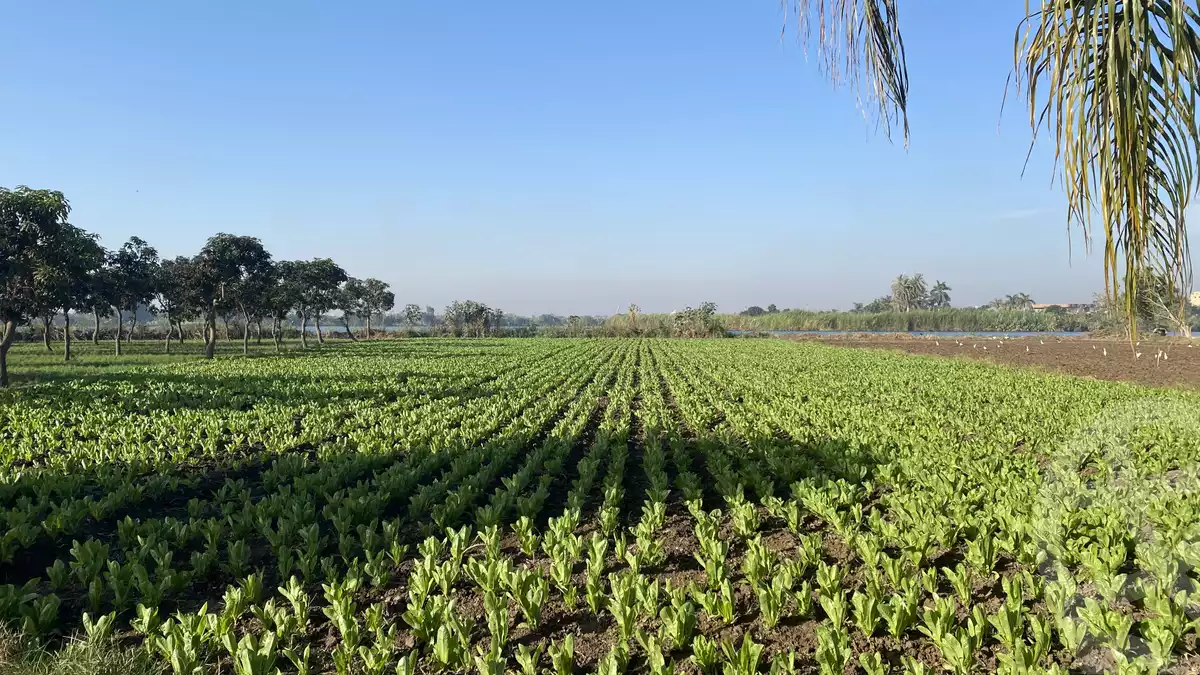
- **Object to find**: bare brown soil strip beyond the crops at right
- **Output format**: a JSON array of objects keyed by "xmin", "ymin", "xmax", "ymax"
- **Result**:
[{"xmin": 790, "ymin": 334, "xmax": 1200, "ymax": 389}]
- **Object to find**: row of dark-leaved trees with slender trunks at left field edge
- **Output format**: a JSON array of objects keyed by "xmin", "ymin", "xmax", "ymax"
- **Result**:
[{"xmin": 0, "ymin": 186, "xmax": 405, "ymax": 386}]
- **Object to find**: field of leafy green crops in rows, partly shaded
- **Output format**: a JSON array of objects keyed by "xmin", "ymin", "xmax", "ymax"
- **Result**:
[{"xmin": 0, "ymin": 339, "xmax": 1200, "ymax": 675}]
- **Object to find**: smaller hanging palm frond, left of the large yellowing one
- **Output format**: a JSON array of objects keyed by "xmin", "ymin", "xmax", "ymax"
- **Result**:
[{"xmin": 781, "ymin": 0, "xmax": 908, "ymax": 145}]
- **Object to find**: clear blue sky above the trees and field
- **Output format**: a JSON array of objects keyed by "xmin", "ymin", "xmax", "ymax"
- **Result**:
[{"xmin": 0, "ymin": 0, "xmax": 1195, "ymax": 313}]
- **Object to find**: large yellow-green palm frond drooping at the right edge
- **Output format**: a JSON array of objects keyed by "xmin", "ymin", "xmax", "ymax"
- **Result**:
[{"xmin": 1014, "ymin": 0, "xmax": 1200, "ymax": 328}]
